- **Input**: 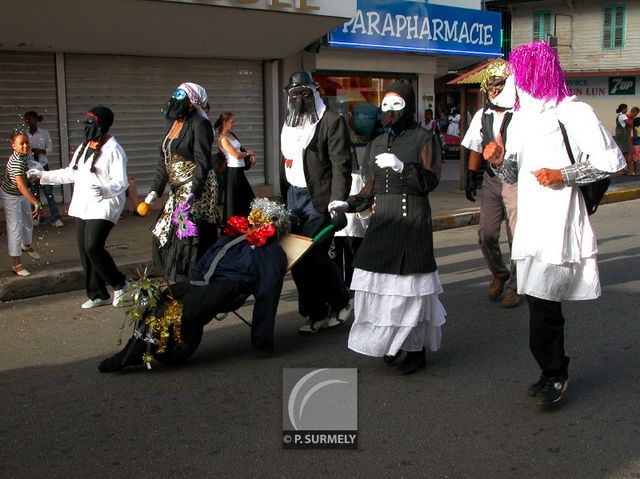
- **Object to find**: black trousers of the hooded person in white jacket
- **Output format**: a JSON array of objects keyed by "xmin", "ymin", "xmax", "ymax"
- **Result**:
[{"xmin": 76, "ymin": 218, "xmax": 126, "ymax": 299}]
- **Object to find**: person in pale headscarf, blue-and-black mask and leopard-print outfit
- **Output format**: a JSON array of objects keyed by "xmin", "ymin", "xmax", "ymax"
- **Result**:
[{"xmin": 139, "ymin": 83, "xmax": 220, "ymax": 281}]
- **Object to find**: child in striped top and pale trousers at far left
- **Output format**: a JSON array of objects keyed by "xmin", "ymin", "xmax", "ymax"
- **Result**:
[{"xmin": 0, "ymin": 131, "xmax": 42, "ymax": 276}]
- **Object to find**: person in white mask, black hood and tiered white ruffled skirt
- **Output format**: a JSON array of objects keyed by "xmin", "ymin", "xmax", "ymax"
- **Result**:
[{"xmin": 329, "ymin": 82, "xmax": 446, "ymax": 374}]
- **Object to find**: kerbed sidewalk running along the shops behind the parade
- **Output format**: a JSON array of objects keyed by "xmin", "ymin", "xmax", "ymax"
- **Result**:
[{"xmin": 0, "ymin": 160, "xmax": 640, "ymax": 301}]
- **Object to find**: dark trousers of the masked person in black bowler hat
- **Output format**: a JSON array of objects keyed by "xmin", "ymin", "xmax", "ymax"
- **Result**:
[{"xmin": 287, "ymin": 186, "xmax": 349, "ymax": 321}]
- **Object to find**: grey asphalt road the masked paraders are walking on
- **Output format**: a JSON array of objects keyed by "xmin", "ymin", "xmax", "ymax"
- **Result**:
[{"xmin": 0, "ymin": 200, "xmax": 640, "ymax": 479}]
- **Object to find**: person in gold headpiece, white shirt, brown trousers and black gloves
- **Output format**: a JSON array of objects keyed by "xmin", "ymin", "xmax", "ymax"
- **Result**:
[{"xmin": 462, "ymin": 60, "xmax": 520, "ymax": 308}]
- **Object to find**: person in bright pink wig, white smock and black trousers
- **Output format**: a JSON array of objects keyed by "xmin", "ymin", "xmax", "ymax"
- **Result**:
[{"xmin": 483, "ymin": 42, "xmax": 625, "ymax": 409}]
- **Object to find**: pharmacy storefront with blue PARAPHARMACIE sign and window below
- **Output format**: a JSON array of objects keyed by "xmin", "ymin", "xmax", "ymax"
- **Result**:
[{"xmin": 307, "ymin": 0, "xmax": 501, "ymax": 155}]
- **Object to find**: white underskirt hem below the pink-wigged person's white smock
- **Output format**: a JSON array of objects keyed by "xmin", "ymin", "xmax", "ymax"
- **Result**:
[{"xmin": 515, "ymin": 256, "xmax": 600, "ymax": 301}]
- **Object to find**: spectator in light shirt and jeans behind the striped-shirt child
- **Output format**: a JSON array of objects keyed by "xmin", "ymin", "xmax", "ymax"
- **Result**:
[{"xmin": 24, "ymin": 111, "xmax": 64, "ymax": 228}]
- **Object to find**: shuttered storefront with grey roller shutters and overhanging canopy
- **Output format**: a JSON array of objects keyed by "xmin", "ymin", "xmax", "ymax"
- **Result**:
[{"xmin": 0, "ymin": 0, "xmax": 355, "ymax": 200}]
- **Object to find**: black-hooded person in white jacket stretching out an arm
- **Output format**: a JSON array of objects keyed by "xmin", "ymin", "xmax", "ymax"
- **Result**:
[{"xmin": 27, "ymin": 106, "xmax": 129, "ymax": 309}]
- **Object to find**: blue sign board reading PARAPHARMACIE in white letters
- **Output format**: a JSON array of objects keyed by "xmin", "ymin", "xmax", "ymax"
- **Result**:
[{"xmin": 329, "ymin": 0, "xmax": 502, "ymax": 57}]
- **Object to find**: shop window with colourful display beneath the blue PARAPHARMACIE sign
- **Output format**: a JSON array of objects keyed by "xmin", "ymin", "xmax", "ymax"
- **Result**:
[{"xmin": 314, "ymin": 74, "xmax": 418, "ymax": 145}]
